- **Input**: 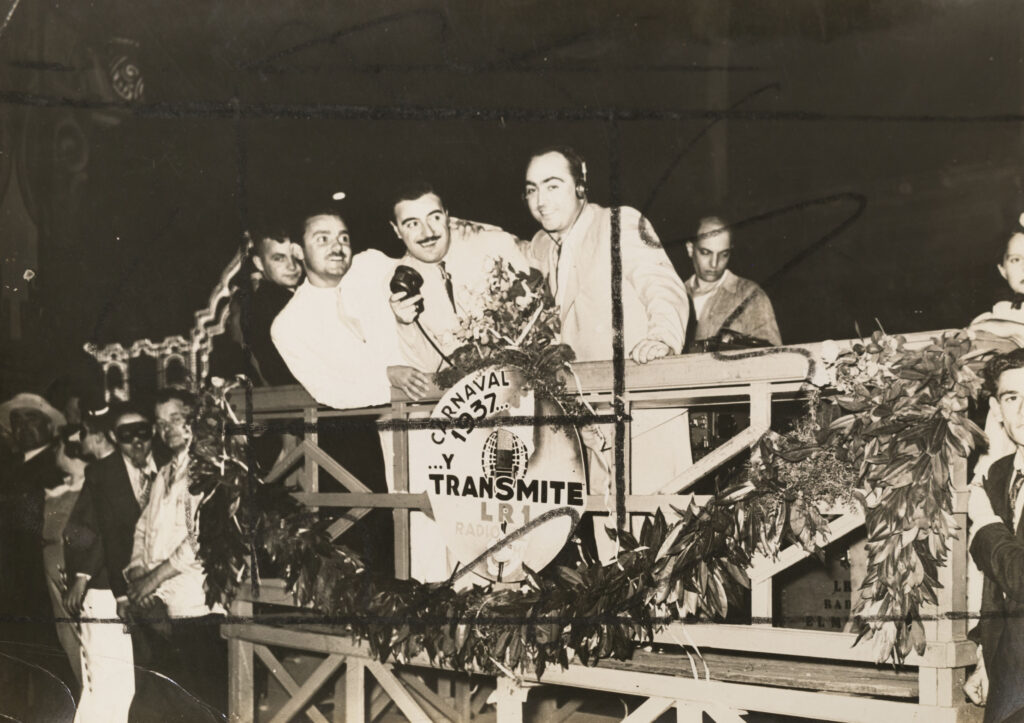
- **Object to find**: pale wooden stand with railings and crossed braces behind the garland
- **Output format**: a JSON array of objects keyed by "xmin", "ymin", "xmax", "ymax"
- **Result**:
[{"xmin": 224, "ymin": 344, "xmax": 982, "ymax": 723}]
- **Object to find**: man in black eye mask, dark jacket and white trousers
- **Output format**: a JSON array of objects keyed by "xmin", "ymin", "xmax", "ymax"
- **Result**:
[{"xmin": 65, "ymin": 408, "xmax": 157, "ymax": 721}]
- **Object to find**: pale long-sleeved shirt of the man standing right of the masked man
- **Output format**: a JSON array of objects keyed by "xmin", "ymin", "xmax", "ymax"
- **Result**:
[{"xmin": 128, "ymin": 449, "xmax": 223, "ymax": 618}]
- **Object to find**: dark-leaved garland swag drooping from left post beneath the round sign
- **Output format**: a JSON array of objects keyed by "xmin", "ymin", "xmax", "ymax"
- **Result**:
[{"xmin": 190, "ymin": 381, "xmax": 750, "ymax": 675}]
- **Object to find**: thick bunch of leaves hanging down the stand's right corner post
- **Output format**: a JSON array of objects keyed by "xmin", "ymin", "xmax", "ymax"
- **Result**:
[{"xmin": 811, "ymin": 332, "xmax": 984, "ymax": 661}]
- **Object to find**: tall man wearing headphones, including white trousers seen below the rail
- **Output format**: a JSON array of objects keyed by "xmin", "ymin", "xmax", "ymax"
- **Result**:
[{"xmin": 524, "ymin": 146, "xmax": 692, "ymax": 559}]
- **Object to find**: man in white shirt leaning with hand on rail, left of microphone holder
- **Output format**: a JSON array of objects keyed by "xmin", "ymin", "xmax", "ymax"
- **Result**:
[{"xmin": 270, "ymin": 210, "xmax": 430, "ymax": 572}]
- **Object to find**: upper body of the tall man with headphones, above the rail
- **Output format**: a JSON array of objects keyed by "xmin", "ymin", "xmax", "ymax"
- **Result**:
[{"xmin": 524, "ymin": 146, "xmax": 689, "ymax": 364}]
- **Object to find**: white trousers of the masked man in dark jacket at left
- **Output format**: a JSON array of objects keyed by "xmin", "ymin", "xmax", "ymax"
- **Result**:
[{"xmin": 75, "ymin": 590, "xmax": 135, "ymax": 723}]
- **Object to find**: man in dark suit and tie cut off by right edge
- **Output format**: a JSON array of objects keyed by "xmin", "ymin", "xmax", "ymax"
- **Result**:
[{"xmin": 965, "ymin": 349, "xmax": 1024, "ymax": 723}]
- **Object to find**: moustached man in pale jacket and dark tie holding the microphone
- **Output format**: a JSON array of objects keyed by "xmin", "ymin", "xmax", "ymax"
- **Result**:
[{"xmin": 382, "ymin": 182, "xmax": 529, "ymax": 372}]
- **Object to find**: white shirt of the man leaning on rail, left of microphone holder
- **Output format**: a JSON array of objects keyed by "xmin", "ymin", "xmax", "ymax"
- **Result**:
[{"xmin": 270, "ymin": 250, "xmax": 401, "ymax": 409}]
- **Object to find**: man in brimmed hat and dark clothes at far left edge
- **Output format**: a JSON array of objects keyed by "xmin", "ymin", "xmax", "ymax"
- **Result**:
[{"xmin": 0, "ymin": 393, "xmax": 65, "ymax": 679}]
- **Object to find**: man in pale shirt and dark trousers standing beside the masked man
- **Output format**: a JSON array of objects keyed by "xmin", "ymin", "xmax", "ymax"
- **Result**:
[{"xmin": 125, "ymin": 389, "xmax": 227, "ymax": 712}]
